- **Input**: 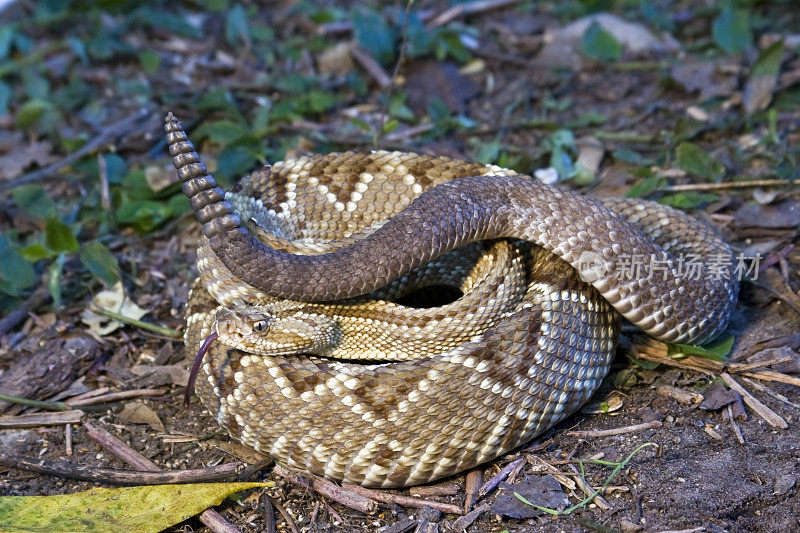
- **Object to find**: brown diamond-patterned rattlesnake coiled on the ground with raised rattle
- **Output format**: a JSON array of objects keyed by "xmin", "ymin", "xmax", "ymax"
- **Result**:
[{"xmin": 165, "ymin": 114, "xmax": 738, "ymax": 487}]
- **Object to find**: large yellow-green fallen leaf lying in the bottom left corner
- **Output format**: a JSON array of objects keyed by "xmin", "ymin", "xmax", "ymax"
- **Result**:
[{"xmin": 0, "ymin": 483, "xmax": 274, "ymax": 533}]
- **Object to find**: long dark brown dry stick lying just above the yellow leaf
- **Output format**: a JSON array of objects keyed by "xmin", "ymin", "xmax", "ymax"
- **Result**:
[{"xmin": 0, "ymin": 452, "xmax": 242, "ymax": 485}]
